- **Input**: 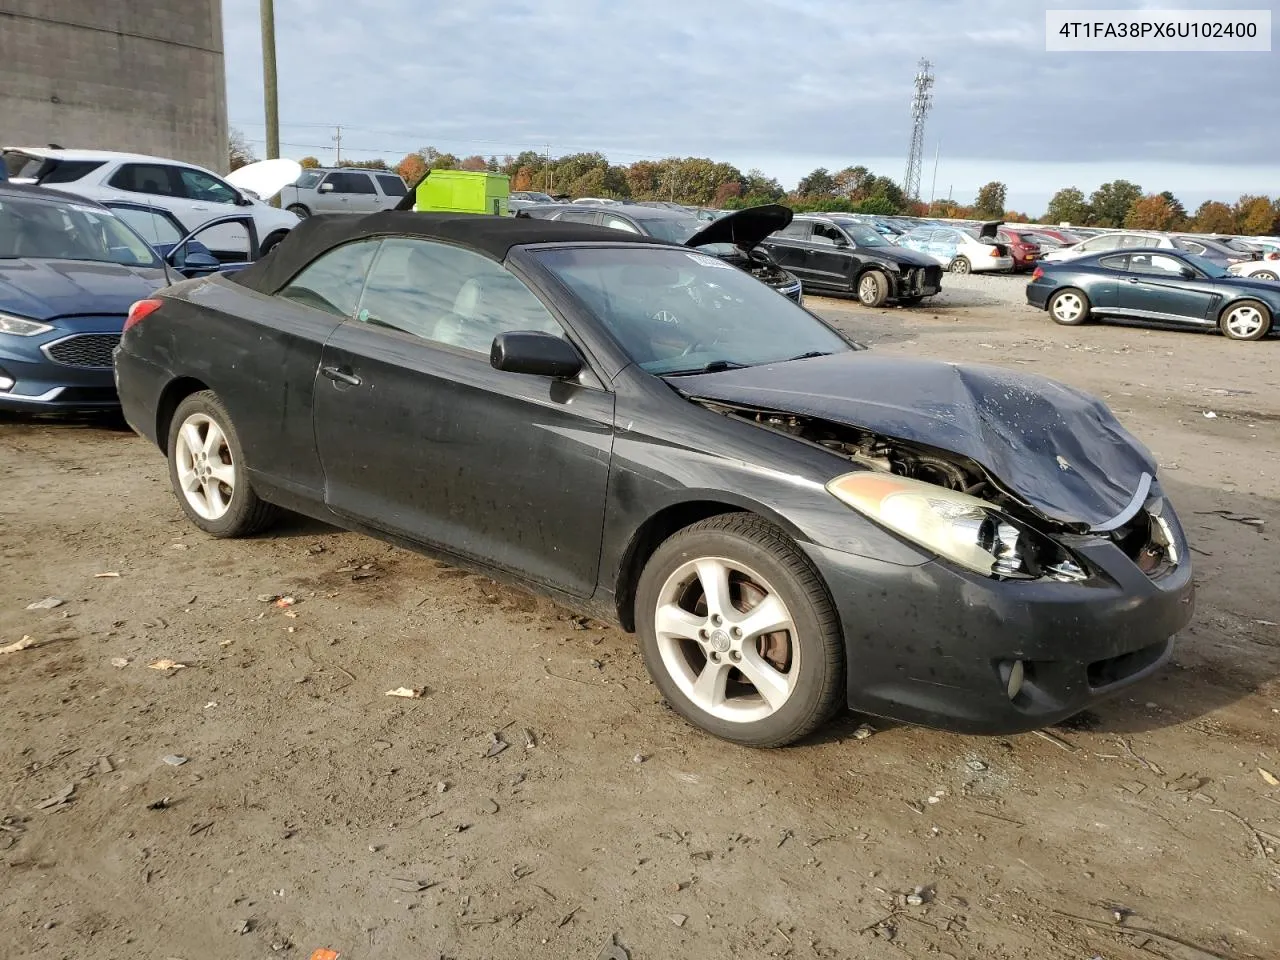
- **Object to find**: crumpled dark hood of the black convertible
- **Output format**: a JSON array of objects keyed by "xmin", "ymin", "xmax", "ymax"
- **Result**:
[{"xmin": 671, "ymin": 351, "xmax": 1156, "ymax": 529}]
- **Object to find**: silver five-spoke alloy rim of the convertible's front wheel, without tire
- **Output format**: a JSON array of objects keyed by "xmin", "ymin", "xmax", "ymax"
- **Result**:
[{"xmin": 654, "ymin": 557, "xmax": 800, "ymax": 723}]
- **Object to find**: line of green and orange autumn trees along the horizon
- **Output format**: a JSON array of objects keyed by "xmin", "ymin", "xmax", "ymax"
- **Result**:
[{"xmin": 230, "ymin": 131, "xmax": 1280, "ymax": 234}]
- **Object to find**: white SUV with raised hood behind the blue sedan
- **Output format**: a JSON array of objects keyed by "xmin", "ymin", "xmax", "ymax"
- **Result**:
[{"xmin": 3, "ymin": 147, "xmax": 301, "ymax": 253}]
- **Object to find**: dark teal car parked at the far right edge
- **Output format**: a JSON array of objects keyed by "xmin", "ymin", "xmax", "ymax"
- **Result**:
[{"xmin": 1027, "ymin": 248, "xmax": 1280, "ymax": 340}]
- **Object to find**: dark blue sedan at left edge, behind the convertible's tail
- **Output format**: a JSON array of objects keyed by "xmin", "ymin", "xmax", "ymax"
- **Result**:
[{"xmin": 0, "ymin": 183, "xmax": 172, "ymax": 412}]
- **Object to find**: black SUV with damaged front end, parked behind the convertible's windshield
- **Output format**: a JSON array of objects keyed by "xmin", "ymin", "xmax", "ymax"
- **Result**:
[{"xmin": 763, "ymin": 214, "xmax": 942, "ymax": 307}]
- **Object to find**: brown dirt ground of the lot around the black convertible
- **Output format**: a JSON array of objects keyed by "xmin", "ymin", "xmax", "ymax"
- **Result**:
[{"xmin": 0, "ymin": 293, "xmax": 1280, "ymax": 960}]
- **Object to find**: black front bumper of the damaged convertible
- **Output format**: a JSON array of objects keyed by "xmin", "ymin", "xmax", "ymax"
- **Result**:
[{"xmin": 804, "ymin": 529, "xmax": 1194, "ymax": 735}]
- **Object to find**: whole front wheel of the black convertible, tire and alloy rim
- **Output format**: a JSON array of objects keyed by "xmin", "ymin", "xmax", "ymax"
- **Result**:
[{"xmin": 636, "ymin": 513, "xmax": 845, "ymax": 746}]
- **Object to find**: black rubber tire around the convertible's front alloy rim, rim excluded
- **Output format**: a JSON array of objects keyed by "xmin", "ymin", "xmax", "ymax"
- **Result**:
[{"xmin": 635, "ymin": 513, "xmax": 845, "ymax": 748}]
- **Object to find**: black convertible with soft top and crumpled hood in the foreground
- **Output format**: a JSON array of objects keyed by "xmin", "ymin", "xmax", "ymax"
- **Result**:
[{"xmin": 116, "ymin": 212, "xmax": 1193, "ymax": 746}]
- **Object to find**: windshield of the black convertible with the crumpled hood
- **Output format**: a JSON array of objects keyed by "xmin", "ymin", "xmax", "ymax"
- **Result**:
[{"xmin": 536, "ymin": 247, "xmax": 851, "ymax": 375}]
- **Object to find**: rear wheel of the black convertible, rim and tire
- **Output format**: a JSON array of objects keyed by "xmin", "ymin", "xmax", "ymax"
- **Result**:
[{"xmin": 168, "ymin": 390, "xmax": 279, "ymax": 538}]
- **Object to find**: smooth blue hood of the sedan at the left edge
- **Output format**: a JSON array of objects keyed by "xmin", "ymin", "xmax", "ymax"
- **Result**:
[{"xmin": 0, "ymin": 259, "xmax": 169, "ymax": 320}]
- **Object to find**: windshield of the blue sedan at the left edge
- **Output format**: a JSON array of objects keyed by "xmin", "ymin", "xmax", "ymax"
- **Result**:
[{"xmin": 0, "ymin": 196, "xmax": 160, "ymax": 266}]
